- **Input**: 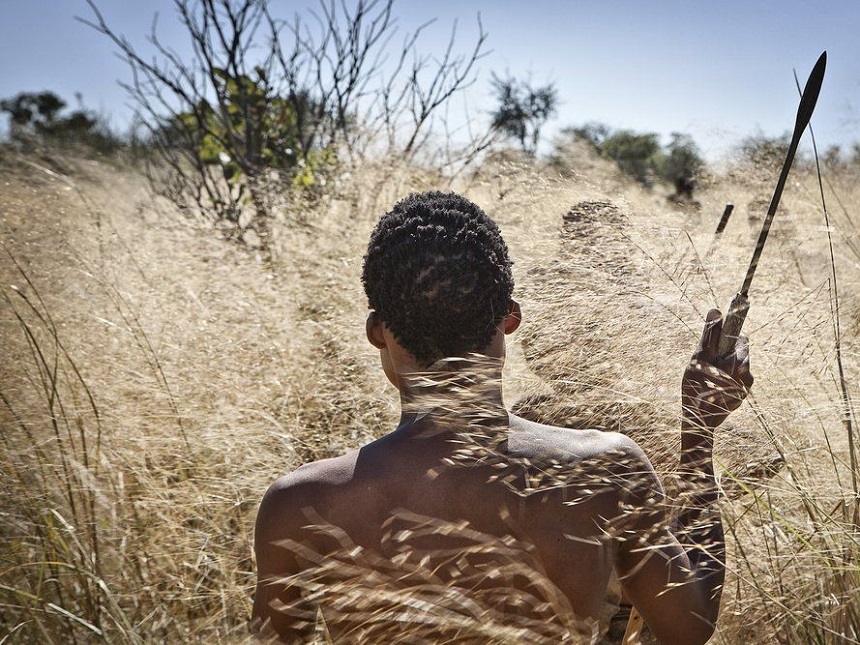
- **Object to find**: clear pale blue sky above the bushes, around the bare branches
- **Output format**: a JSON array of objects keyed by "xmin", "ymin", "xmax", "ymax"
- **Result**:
[{"xmin": 0, "ymin": 0, "xmax": 860, "ymax": 158}]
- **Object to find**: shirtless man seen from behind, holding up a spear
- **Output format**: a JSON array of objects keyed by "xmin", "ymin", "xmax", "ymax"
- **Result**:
[{"xmin": 253, "ymin": 192, "xmax": 752, "ymax": 643}]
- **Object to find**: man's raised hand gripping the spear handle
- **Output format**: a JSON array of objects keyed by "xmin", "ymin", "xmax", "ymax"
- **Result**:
[{"xmin": 681, "ymin": 309, "xmax": 753, "ymax": 444}]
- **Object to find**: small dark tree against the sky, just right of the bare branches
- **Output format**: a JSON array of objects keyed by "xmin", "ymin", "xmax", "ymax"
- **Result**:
[{"xmin": 490, "ymin": 74, "xmax": 558, "ymax": 156}]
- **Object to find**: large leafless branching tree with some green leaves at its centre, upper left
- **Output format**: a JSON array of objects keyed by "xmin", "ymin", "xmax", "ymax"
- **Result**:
[{"xmin": 80, "ymin": 0, "xmax": 486, "ymax": 254}]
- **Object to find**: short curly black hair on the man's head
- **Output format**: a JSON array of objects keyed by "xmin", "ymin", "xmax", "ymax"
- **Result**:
[{"xmin": 361, "ymin": 192, "xmax": 514, "ymax": 365}]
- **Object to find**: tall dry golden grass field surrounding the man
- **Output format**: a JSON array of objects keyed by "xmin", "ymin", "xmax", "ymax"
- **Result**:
[{"xmin": 0, "ymin": 143, "xmax": 860, "ymax": 643}]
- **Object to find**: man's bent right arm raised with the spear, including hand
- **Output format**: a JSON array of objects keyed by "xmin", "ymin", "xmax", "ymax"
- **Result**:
[{"xmin": 618, "ymin": 309, "xmax": 753, "ymax": 643}]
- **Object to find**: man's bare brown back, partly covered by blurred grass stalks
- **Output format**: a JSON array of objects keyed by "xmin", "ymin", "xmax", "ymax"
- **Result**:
[{"xmin": 255, "ymin": 416, "xmax": 650, "ymax": 640}]
